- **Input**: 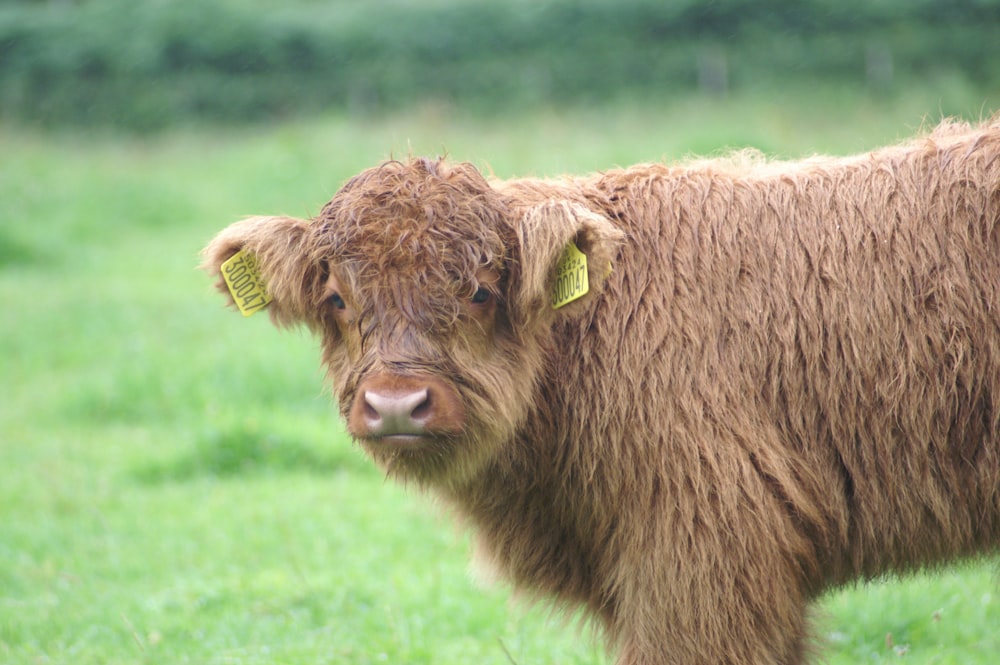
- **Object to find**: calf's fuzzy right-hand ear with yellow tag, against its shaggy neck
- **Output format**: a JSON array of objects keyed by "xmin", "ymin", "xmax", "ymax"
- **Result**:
[{"xmin": 510, "ymin": 201, "xmax": 625, "ymax": 326}]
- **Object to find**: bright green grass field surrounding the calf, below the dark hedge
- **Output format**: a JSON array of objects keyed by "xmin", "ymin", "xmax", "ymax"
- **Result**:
[{"xmin": 0, "ymin": 88, "xmax": 1000, "ymax": 665}]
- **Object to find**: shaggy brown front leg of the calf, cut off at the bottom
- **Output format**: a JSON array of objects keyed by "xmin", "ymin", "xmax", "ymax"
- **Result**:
[{"xmin": 609, "ymin": 464, "xmax": 815, "ymax": 665}]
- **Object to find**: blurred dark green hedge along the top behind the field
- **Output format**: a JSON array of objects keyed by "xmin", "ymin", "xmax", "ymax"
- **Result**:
[{"xmin": 0, "ymin": 0, "xmax": 1000, "ymax": 130}]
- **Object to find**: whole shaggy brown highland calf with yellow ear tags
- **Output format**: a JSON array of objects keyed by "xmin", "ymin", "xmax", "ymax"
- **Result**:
[{"xmin": 205, "ymin": 117, "xmax": 1000, "ymax": 665}]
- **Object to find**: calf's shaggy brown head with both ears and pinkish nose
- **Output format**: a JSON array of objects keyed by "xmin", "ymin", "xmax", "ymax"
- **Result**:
[{"xmin": 206, "ymin": 160, "xmax": 621, "ymax": 482}]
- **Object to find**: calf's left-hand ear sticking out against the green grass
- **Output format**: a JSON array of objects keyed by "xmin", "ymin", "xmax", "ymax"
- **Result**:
[{"xmin": 201, "ymin": 217, "xmax": 319, "ymax": 326}]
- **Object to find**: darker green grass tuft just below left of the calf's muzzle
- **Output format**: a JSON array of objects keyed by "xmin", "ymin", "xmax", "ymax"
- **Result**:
[{"xmin": 133, "ymin": 425, "xmax": 373, "ymax": 483}]
